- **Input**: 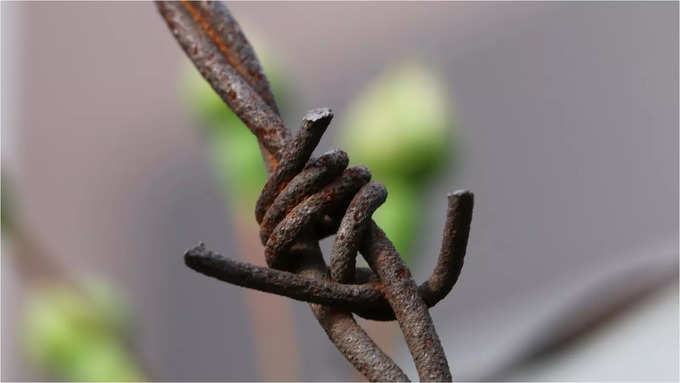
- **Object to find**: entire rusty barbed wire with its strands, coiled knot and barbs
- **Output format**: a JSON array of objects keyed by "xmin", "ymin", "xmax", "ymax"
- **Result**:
[{"xmin": 157, "ymin": 1, "xmax": 473, "ymax": 381}]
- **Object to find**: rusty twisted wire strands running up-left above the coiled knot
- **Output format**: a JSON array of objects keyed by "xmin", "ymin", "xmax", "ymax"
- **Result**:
[{"xmin": 156, "ymin": 1, "xmax": 288, "ymax": 169}]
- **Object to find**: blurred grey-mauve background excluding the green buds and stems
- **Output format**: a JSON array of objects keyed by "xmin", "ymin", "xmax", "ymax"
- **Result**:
[{"xmin": 2, "ymin": 2, "xmax": 678, "ymax": 380}]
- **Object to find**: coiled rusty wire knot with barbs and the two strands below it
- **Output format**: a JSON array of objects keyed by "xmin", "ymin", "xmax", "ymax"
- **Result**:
[{"xmin": 185, "ymin": 109, "xmax": 473, "ymax": 380}]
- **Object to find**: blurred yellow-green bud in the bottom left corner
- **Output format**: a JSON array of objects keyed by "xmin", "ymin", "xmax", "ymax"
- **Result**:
[{"xmin": 22, "ymin": 279, "xmax": 144, "ymax": 381}]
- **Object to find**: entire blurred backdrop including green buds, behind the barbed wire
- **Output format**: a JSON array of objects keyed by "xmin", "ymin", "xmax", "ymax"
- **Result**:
[{"xmin": 1, "ymin": 2, "xmax": 679, "ymax": 381}]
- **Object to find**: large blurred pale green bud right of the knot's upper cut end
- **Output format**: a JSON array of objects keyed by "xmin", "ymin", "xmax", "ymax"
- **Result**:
[{"xmin": 341, "ymin": 63, "xmax": 453, "ymax": 183}]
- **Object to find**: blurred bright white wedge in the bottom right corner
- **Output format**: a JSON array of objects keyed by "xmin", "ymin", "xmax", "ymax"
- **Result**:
[{"xmin": 506, "ymin": 283, "xmax": 678, "ymax": 381}]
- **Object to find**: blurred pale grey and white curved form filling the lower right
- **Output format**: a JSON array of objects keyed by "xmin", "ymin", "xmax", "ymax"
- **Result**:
[{"xmin": 399, "ymin": 238, "xmax": 679, "ymax": 381}]
